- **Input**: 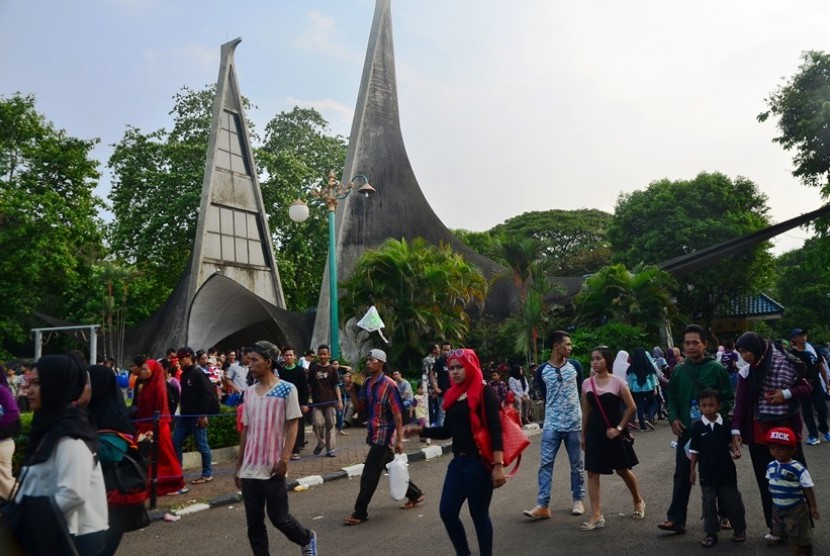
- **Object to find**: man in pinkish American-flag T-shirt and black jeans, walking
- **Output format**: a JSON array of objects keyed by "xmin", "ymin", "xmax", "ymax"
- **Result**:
[{"xmin": 235, "ymin": 340, "xmax": 317, "ymax": 556}]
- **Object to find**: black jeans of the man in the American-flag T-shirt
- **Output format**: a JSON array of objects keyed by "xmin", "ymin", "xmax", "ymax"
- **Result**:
[{"xmin": 242, "ymin": 477, "xmax": 311, "ymax": 556}]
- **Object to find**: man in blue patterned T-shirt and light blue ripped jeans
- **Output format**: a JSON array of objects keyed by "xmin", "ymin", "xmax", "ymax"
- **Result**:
[{"xmin": 523, "ymin": 330, "xmax": 585, "ymax": 520}]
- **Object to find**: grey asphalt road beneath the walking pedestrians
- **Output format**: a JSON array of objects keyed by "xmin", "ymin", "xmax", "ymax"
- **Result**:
[{"xmin": 118, "ymin": 422, "xmax": 830, "ymax": 556}]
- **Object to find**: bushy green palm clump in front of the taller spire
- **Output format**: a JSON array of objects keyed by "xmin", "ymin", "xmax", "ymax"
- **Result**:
[{"xmin": 341, "ymin": 238, "xmax": 487, "ymax": 368}]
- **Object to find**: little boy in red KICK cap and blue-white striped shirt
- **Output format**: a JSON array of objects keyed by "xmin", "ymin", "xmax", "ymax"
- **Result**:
[{"xmin": 765, "ymin": 427, "xmax": 819, "ymax": 555}]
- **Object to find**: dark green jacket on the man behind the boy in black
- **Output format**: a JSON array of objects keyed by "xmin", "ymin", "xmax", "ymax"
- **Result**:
[{"xmin": 666, "ymin": 357, "xmax": 735, "ymax": 438}]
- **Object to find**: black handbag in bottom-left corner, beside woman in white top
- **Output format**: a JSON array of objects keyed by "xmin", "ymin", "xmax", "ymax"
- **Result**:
[{"xmin": 0, "ymin": 472, "xmax": 78, "ymax": 556}]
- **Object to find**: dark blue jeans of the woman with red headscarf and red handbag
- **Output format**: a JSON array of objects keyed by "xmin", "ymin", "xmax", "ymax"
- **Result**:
[{"xmin": 438, "ymin": 456, "xmax": 493, "ymax": 556}]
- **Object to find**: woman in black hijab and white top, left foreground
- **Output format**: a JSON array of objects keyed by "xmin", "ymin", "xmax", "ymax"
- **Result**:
[{"xmin": 16, "ymin": 355, "xmax": 107, "ymax": 556}]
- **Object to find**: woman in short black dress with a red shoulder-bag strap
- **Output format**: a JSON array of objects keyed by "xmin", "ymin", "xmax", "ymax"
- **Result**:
[{"xmin": 580, "ymin": 346, "xmax": 646, "ymax": 531}]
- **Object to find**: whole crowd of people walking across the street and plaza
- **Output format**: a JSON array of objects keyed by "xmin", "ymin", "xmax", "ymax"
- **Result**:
[{"xmin": 0, "ymin": 325, "xmax": 830, "ymax": 554}]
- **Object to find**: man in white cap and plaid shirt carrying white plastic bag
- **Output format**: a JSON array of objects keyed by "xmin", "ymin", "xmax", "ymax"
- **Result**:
[{"xmin": 343, "ymin": 349, "xmax": 424, "ymax": 525}]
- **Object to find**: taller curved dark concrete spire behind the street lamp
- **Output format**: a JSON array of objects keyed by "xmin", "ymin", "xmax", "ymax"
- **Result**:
[{"xmin": 314, "ymin": 0, "xmax": 510, "ymax": 358}]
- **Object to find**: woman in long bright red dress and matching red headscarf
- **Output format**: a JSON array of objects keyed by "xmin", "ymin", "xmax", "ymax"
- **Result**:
[{"xmin": 135, "ymin": 359, "xmax": 187, "ymax": 495}]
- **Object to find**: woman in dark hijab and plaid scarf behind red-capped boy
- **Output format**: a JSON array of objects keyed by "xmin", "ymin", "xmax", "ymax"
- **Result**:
[{"xmin": 732, "ymin": 332, "xmax": 812, "ymax": 545}]
